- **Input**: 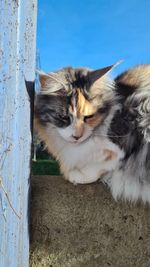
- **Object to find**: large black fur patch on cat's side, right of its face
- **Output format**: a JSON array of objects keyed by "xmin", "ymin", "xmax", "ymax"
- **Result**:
[{"xmin": 108, "ymin": 73, "xmax": 150, "ymax": 160}]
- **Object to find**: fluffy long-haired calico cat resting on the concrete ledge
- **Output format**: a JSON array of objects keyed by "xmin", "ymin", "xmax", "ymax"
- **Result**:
[{"xmin": 35, "ymin": 65, "xmax": 150, "ymax": 202}]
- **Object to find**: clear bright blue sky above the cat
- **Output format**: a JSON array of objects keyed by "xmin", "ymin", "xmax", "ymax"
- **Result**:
[{"xmin": 37, "ymin": 0, "xmax": 150, "ymax": 77}]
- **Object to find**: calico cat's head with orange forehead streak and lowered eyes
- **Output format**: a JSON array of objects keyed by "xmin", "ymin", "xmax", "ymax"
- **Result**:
[{"xmin": 35, "ymin": 65, "xmax": 114, "ymax": 143}]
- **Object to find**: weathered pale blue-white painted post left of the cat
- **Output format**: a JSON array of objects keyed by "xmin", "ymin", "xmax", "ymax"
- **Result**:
[{"xmin": 0, "ymin": 0, "xmax": 37, "ymax": 267}]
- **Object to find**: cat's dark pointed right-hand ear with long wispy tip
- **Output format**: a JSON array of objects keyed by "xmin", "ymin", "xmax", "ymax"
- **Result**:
[{"xmin": 88, "ymin": 61, "xmax": 122, "ymax": 85}]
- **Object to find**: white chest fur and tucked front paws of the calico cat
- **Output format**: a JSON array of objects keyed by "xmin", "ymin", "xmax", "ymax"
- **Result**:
[{"xmin": 45, "ymin": 126, "xmax": 124, "ymax": 184}]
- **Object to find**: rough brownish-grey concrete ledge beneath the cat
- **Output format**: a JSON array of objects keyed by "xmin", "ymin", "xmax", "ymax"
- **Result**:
[{"xmin": 30, "ymin": 176, "xmax": 150, "ymax": 267}]
